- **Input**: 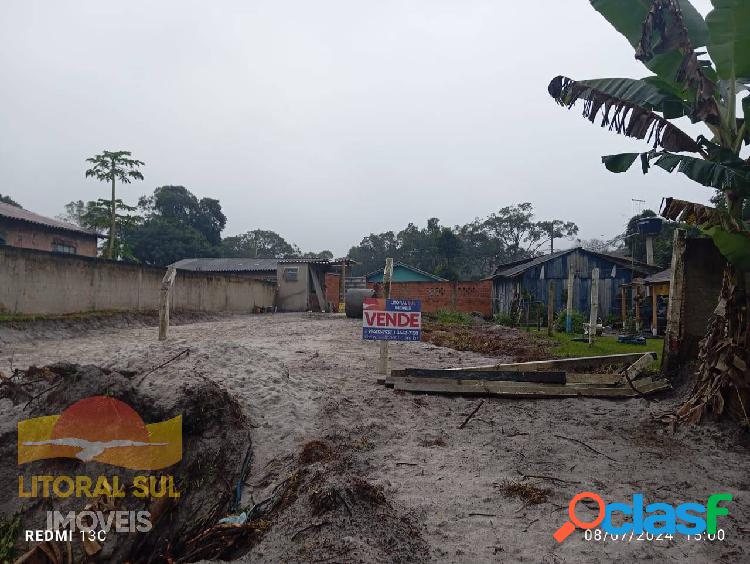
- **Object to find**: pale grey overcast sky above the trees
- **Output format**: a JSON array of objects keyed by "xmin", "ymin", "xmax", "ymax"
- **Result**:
[{"xmin": 0, "ymin": 0, "xmax": 711, "ymax": 254}]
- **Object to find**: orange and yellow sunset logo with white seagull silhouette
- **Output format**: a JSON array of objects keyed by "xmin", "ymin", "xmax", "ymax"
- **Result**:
[{"xmin": 18, "ymin": 396, "xmax": 182, "ymax": 470}]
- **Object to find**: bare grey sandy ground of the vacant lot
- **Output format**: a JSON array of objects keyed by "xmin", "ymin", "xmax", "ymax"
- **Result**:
[{"xmin": 0, "ymin": 314, "xmax": 750, "ymax": 562}]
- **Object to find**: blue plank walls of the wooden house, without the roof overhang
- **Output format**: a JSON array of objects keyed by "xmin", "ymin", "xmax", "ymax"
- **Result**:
[{"xmin": 492, "ymin": 251, "xmax": 632, "ymax": 319}]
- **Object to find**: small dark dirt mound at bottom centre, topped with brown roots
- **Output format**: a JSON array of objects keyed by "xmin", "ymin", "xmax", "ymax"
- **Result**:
[{"xmin": 248, "ymin": 439, "xmax": 429, "ymax": 562}]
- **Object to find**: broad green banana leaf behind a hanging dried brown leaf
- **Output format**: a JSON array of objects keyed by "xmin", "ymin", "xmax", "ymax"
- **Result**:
[{"xmin": 590, "ymin": 0, "xmax": 712, "ymax": 83}]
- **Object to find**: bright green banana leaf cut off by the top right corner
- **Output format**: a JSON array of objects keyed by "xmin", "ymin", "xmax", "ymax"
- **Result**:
[{"xmin": 706, "ymin": 0, "xmax": 750, "ymax": 80}]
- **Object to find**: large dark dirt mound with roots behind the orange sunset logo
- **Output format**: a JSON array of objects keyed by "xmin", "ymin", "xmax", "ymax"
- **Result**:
[{"xmin": 0, "ymin": 364, "xmax": 251, "ymax": 562}]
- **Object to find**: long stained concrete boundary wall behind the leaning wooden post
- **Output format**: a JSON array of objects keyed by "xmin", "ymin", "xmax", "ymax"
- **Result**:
[{"xmin": 0, "ymin": 246, "xmax": 276, "ymax": 314}]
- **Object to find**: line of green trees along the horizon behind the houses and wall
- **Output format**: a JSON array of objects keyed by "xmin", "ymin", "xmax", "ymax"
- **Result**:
[{"xmin": 0, "ymin": 151, "xmax": 696, "ymax": 280}]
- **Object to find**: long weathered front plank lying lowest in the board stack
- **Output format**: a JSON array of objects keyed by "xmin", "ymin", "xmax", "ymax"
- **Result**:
[{"xmin": 394, "ymin": 378, "xmax": 670, "ymax": 398}]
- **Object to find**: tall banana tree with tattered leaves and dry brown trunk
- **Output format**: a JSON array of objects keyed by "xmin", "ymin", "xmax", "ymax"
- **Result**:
[{"xmin": 549, "ymin": 0, "xmax": 750, "ymax": 424}]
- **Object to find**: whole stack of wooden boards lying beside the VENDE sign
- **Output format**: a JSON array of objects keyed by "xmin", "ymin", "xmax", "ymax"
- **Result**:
[{"xmin": 378, "ymin": 352, "xmax": 671, "ymax": 398}]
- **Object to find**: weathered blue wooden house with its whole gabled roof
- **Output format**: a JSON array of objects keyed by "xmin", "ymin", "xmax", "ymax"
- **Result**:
[{"xmin": 492, "ymin": 248, "xmax": 661, "ymax": 319}]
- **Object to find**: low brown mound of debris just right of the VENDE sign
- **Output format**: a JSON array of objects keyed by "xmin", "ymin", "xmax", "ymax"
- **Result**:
[{"xmin": 422, "ymin": 320, "xmax": 554, "ymax": 362}]
